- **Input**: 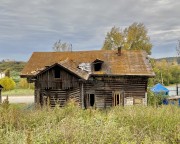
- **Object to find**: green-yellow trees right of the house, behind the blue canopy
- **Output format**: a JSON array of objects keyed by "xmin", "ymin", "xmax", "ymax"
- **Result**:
[{"xmin": 149, "ymin": 59, "xmax": 180, "ymax": 86}]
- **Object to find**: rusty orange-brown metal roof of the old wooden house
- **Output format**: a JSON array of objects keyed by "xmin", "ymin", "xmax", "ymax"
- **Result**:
[{"xmin": 21, "ymin": 50, "xmax": 154, "ymax": 79}]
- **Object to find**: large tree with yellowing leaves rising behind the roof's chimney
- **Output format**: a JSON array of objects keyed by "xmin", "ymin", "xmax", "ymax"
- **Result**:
[{"xmin": 102, "ymin": 23, "xmax": 152, "ymax": 54}]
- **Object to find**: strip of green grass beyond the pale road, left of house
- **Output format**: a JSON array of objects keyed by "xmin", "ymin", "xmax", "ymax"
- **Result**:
[{"xmin": 2, "ymin": 89, "xmax": 34, "ymax": 96}]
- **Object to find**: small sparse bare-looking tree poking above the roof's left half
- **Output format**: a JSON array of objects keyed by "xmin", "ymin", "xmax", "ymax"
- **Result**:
[{"xmin": 53, "ymin": 40, "xmax": 72, "ymax": 52}]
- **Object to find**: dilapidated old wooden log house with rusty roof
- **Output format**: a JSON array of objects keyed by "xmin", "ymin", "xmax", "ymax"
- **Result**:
[{"xmin": 21, "ymin": 48, "xmax": 154, "ymax": 108}]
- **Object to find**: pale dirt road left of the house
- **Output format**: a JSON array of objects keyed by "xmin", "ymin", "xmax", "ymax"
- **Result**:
[{"xmin": 2, "ymin": 96, "xmax": 34, "ymax": 103}]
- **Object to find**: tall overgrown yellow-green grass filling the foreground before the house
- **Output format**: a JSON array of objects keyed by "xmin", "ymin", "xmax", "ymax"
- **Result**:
[{"xmin": 0, "ymin": 100, "xmax": 180, "ymax": 144}]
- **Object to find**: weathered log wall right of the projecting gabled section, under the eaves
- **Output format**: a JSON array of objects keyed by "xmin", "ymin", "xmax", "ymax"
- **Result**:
[{"xmin": 84, "ymin": 77, "xmax": 147, "ymax": 108}]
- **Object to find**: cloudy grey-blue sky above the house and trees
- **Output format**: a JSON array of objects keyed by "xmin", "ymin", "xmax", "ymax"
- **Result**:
[{"xmin": 0, "ymin": 0, "xmax": 180, "ymax": 61}]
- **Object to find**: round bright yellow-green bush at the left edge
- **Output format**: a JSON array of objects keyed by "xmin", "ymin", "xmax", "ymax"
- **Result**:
[{"xmin": 0, "ymin": 77, "xmax": 16, "ymax": 91}]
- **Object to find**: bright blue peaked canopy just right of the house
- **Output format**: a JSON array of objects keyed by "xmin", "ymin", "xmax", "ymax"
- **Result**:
[{"xmin": 151, "ymin": 83, "xmax": 169, "ymax": 95}]
